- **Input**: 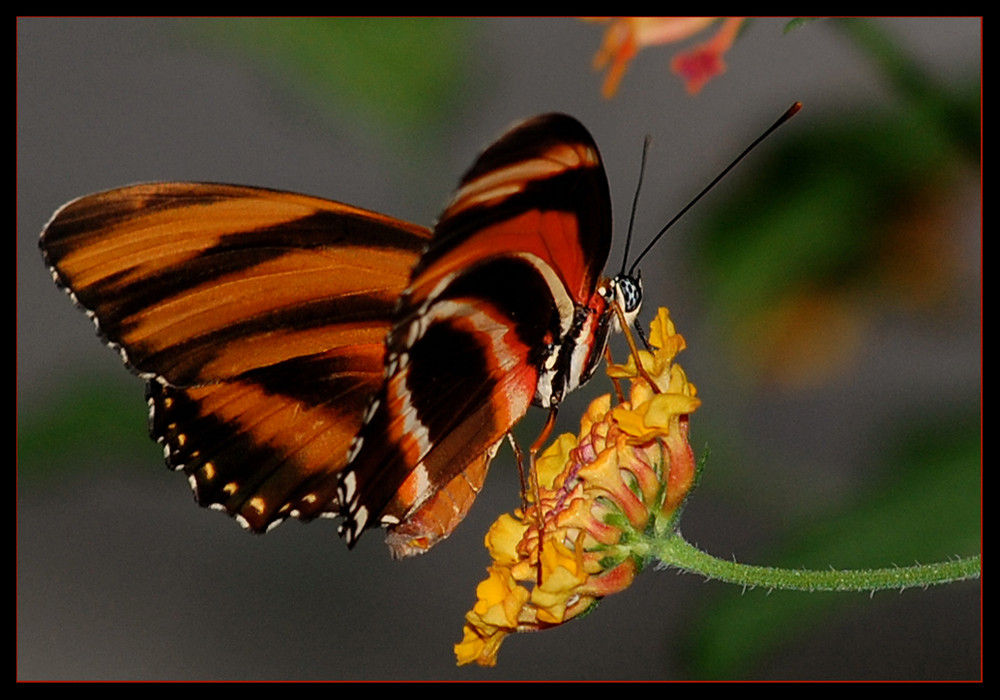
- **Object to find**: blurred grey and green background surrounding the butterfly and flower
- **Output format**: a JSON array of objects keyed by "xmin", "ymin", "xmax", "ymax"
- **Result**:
[{"xmin": 17, "ymin": 19, "xmax": 982, "ymax": 680}]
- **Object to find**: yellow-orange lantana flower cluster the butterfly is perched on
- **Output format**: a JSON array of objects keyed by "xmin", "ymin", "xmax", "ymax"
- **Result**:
[{"xmin": 455, "ymin": 309, "xmax": 700, "ymax": 666}]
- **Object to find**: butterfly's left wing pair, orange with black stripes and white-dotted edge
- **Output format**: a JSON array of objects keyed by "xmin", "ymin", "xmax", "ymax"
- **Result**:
[{"xmin": 41, "ymin": 183, "xmax": 430, "ymax": 532}]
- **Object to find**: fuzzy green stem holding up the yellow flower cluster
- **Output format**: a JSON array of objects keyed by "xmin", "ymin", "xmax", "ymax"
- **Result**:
[{"xmin": 652, "ymin": 534, "xmax": 980, "ymax": 591}]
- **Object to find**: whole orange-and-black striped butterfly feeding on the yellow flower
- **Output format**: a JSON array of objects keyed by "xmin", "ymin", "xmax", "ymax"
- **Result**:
[{"xmin": 40, "ymin": 114, "xmax": 641, "ymax": 556}]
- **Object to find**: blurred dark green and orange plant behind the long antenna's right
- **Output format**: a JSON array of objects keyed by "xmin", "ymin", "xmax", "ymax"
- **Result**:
[{"xmin": 693, "ymin": 20, "xmax": 981, "ymax": 383}]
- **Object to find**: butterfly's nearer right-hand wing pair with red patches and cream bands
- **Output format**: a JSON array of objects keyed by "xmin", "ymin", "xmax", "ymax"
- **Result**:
[{"xmin": 340, "ymin": 114, "xmax": 611, "ymax": 555}]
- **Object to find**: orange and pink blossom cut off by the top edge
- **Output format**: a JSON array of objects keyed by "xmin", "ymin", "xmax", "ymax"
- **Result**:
[{"xmin": 594, "ymin": 17, "xmax": 746, "ymax": 97}]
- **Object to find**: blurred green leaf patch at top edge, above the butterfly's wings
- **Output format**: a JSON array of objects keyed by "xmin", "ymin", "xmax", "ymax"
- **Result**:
[{"xmin": 183, "ymin": 17, "xmax": 476, "ymax": 136}]
